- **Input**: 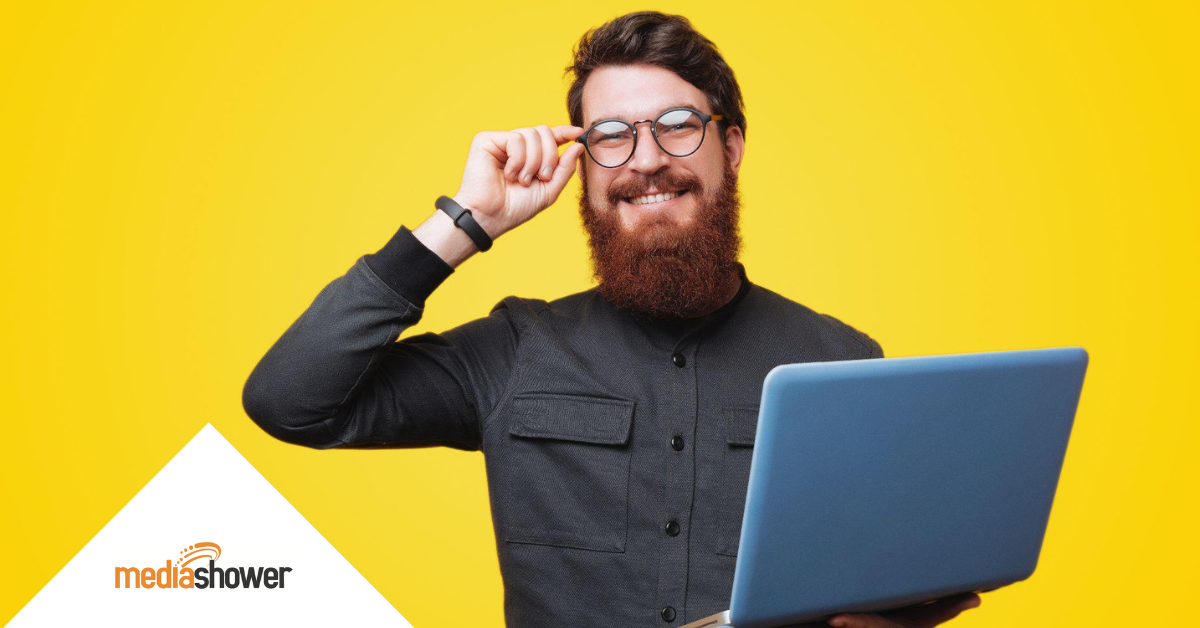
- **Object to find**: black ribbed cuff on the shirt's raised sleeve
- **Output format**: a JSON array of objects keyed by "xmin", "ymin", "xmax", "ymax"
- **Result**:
[{"xmin": 364, "ymin": 226, "xmax": 454, "ymax": 307}]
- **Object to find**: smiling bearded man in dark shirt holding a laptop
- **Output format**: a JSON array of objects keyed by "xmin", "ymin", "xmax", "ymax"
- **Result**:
[{"xmin": 244, "ymin": 12, "xmax": 978, "ymax": 628}]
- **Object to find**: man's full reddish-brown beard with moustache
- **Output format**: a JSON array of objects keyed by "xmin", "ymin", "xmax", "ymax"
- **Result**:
[{"xmin": 580, "ymin": 162, "xmax": 742, "ymax": 319}]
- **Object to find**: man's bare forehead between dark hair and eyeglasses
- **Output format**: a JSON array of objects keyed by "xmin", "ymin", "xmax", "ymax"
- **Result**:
[{"xmin": 582, "ymin": 65, "xmax": 712, "ymax": 127}]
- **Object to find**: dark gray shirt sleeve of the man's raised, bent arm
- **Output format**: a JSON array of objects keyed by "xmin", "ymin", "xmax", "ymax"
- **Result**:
[{"xmin": 242, "ymin": 227, "xmax": 517, "ymax": 450}]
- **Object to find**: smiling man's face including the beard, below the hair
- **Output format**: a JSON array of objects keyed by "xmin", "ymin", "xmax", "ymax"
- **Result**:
[{"xmin": 580, "ymin": 65, "xmax": 744, "ymax": 318}]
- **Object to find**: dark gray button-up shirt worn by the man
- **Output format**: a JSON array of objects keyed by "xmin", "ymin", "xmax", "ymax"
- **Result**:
[{"xmin": 244, "ymin": 227, "xmax": 883, "ymax": 628}]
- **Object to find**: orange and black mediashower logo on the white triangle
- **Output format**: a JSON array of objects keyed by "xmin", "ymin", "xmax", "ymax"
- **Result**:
[{"xmin": 114, "ymin": 542, "xmax": 292, "ymax": 588}]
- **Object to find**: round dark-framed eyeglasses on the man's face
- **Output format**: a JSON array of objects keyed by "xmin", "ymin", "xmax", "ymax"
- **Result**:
[{"xmin": 576, "ymin": 107, "xmax": 722, "ymax": 168}]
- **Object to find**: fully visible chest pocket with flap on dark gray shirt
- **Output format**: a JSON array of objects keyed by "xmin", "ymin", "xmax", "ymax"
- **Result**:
[{"xmin": 504, "ymin": 394, "xmax": 634, "ymax": 552}]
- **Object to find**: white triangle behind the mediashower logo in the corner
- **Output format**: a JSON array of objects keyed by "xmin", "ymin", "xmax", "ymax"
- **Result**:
[{"xmin": 8, "ymin": 424, "xmax": 412, "ymax": 628}]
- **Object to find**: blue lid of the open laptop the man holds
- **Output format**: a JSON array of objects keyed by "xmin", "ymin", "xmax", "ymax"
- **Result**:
[{"xmin": 730, "ymin": 347, "xmax": 1087, "ymax": 628}]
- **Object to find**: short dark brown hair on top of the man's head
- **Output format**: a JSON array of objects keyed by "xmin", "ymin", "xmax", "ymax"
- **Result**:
[{"xmin": 566, "ymin": 11, "xmax": 746, "ymax": 136}]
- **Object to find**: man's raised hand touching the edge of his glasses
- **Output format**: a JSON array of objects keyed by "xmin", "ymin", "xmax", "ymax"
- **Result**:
[{"xmin": 454, "ymin": 125, "xmax": 584, "ymax": 238}]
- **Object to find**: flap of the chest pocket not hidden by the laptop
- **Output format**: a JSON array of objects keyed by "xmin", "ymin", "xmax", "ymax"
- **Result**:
[{"xmin": 509, "ymin": 394, "xmax": 634, "ymax": 444}]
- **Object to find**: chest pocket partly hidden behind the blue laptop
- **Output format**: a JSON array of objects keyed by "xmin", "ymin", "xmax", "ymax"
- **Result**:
[{"xmin": 716, "ymin": 406, "xmax": 758, "ymax": 556}]
